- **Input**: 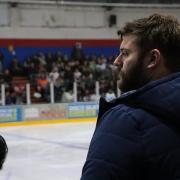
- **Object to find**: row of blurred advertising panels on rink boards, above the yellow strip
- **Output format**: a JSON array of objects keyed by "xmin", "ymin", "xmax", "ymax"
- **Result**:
[{"xmin": 0, "ymin": 102, "xmax": 99, "ymax": 123}]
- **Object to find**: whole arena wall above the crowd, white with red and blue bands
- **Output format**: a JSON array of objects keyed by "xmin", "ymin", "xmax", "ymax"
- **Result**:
[{"xmin": 0, "ymin": 3, "xmax": 180, "ymax": 68}]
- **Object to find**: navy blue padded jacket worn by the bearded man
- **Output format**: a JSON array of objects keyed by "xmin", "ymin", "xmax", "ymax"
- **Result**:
[{"xmin": 81, "ymin": 73, "xmax": 180, "ymax": 180}]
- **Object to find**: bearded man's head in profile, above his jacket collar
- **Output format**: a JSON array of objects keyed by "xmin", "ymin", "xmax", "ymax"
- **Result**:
[{"xmin": 114, "ymin": 14, "xmax": 180, "ymax": 92}]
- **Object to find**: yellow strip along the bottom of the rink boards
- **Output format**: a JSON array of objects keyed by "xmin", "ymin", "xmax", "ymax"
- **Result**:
[{"xmin": 0, "ymin": 118, "xmax": 96, "ymax": 127}]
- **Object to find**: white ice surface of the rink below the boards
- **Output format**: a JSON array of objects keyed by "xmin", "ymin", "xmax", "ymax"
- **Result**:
[{"xmin": 0, "ymin": 122, "xmax": 95, "ymax": 180}]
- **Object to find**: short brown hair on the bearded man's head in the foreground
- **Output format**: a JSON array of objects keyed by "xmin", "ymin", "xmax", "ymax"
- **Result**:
[{"xmin": 118, "ymin": 13, "xmax": 180, "ymax": 72}]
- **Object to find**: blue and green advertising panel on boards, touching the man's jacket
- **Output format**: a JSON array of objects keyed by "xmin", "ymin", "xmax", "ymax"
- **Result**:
[{"xmin": 68, "ymin": 103, "xmax": 99, "ymax": 118}]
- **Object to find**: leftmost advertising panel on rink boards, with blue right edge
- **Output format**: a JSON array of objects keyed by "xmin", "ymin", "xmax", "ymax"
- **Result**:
[{"xmin": 0, "ymin": 107, "xmax": 22, "ymax": 122}]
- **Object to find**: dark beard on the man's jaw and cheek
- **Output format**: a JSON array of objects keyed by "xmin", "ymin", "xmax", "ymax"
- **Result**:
[{"xmin": 119, "ymin": 56, "xmax": 148, "ymax": 93}]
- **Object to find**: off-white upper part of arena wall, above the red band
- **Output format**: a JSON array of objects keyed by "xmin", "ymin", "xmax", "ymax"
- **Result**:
[{"xmin": 0, "ymin": 3, "xmax": 180, "ymax": 39}]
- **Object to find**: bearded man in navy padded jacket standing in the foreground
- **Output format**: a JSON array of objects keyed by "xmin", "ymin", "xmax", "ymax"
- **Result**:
[{"xmin": 81, "ymin": 14, "xmax": 180, "ymax": 180}]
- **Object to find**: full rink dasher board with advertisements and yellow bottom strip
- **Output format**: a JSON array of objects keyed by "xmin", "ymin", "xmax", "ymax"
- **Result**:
[{"xmin": 0, "ymin": 102, "xmax": 99, "ymax": 126}]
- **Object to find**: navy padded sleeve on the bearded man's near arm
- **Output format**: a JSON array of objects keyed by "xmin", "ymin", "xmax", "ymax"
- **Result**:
[{"xmin": 81, "ymin": 107, "xmax": 141, "ymax": 180}]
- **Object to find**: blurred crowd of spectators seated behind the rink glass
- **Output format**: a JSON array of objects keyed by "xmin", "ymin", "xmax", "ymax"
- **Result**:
[{"xmin": 1, "ymin": 43, "xmax": 117, "ymax": 104}]
